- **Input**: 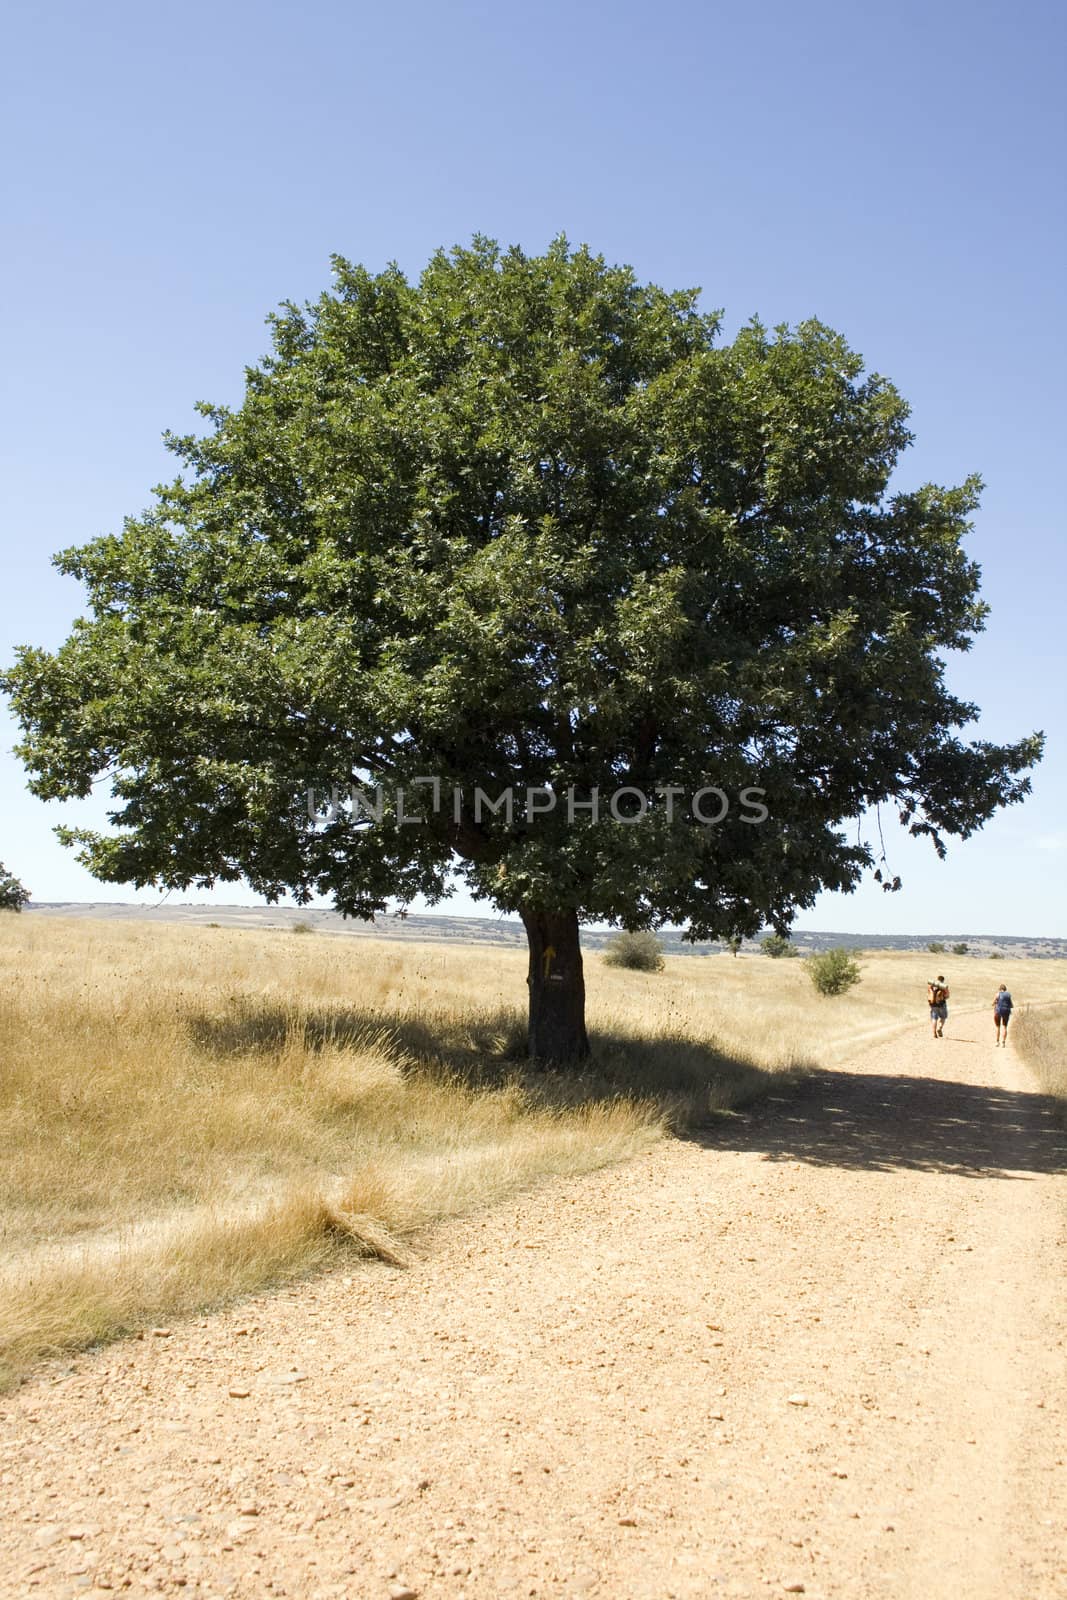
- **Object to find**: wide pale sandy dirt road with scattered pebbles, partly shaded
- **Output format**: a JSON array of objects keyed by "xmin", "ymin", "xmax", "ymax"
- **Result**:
[{"xmin": 0, "ymin": 1014, "xmax": 1067, "ymax": 1600}]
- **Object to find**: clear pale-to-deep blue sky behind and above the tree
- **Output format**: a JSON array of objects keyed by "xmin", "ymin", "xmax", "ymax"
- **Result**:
[{"xmin": 0, "ymin": 0, "xmax": 1067, "ymax": 934}]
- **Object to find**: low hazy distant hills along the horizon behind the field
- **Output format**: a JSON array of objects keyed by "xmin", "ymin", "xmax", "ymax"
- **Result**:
[{"xmin": 27, "ymin": 901, "xmax": 1067, "ymax": 960}]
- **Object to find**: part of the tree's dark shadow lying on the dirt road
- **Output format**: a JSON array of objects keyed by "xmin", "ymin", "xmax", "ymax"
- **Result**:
[{"xmin": 691, "ymin": 1072, "xmax": 1067, "ymax": 1181}]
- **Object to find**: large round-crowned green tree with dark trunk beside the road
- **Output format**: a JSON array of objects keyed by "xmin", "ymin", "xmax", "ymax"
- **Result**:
[{"xmin": 6, "ymin": 238, "xmax": 1040, "ymax": 1059}]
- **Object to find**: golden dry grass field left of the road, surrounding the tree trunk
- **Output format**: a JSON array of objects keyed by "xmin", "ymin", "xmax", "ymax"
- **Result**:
[{"xmin": 0, "ymin": 914, "xmax": 1067, "ymax": 1381}]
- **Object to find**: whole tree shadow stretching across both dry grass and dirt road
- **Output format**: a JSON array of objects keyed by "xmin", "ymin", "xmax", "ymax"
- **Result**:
[{"xmin": 189, "ymin": 1000, "xmax": 1067, "ymax": 1179}]
